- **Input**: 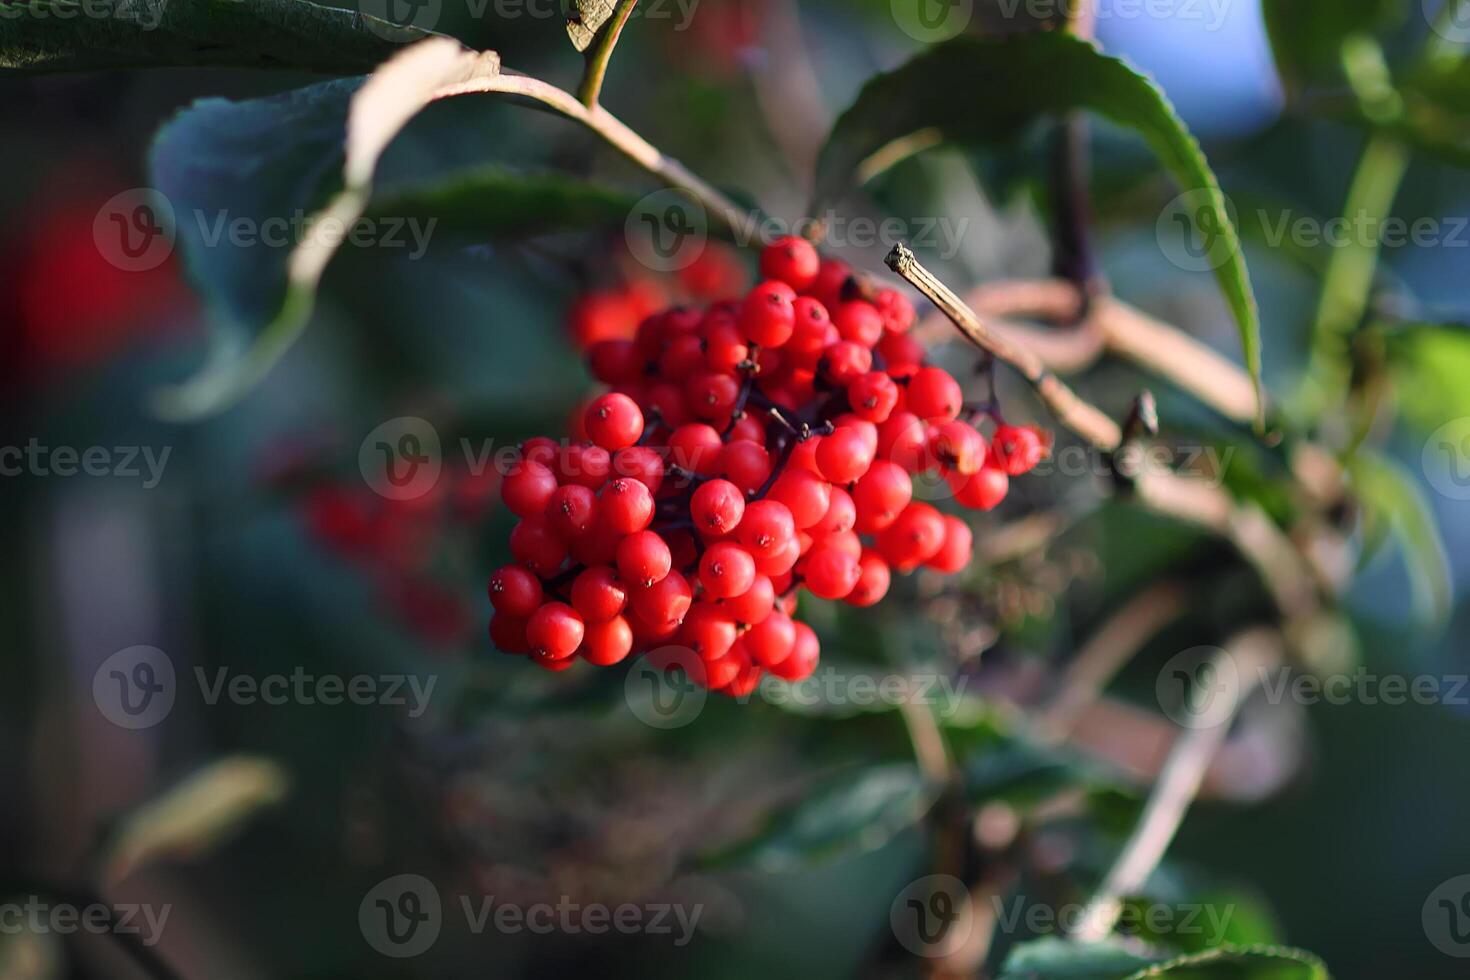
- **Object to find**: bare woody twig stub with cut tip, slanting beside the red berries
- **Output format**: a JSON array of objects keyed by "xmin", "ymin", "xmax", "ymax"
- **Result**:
[{"xmin": 885, "ymin": 242, "xmax": 1123, "ymax": 453}]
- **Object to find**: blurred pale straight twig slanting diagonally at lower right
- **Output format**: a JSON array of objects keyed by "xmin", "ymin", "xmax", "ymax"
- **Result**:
[{"xmin": 1075, "ymin": 629, "xmax": 1280, "ymax": 942}]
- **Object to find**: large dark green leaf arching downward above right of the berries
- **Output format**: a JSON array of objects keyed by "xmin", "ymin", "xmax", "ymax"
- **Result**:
[{"xmin": 814, "ymin": 32, "xmax": 1264, "ymax": 420}]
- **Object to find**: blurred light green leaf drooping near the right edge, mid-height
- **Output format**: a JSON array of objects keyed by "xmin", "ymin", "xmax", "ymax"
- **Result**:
[{"xmin": 1348, "ymin": 450, "xmax": 1451, "ymax": 623}]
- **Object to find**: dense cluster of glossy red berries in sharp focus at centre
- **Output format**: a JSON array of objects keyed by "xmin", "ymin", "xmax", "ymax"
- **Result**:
[{"xmin": 490, "ymin": 238, "xmax": 1045, "ymax": 695}]
